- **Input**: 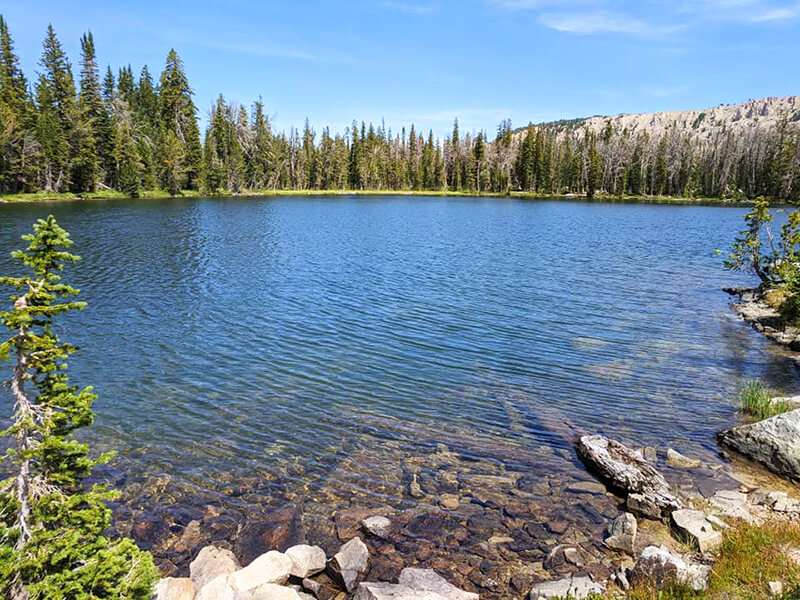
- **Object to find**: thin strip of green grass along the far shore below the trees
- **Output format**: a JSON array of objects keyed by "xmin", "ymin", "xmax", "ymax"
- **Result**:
[{"xmin": 0, "ymin": 190, "xmax": 746, "ymax": 206}]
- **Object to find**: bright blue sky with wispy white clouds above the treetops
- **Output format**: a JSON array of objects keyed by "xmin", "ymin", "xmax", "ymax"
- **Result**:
[{"xmin": 0, "ymin": 0, "xmax": 800, "ymax": 135}]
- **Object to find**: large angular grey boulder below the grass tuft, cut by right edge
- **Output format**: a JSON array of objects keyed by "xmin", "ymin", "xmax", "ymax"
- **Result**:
[{"xmin": 717, "ymin": 409, "xmax": 800, "ymax": 481}]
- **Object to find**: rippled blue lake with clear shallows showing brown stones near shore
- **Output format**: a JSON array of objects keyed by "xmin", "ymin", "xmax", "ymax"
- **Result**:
[{"xmin": 0, "ymin": 195, "xmax": 798, "ymax": 597}]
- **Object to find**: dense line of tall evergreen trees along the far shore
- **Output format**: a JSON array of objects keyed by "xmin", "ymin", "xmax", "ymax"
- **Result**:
[{"xmin": 0, "ymin": 17, "xmax": 800, "ymax": 201}]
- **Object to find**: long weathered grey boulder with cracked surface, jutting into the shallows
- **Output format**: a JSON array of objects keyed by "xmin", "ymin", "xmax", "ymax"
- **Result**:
[{"xmin": 577, "ymin": 435, "xmax": 683, "ymax": 518}]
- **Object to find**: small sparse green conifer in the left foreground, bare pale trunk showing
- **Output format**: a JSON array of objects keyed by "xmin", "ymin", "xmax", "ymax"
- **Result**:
[{"xmin": 0, "ymin": 215, "xmax": 157, "ymax": 600}]
